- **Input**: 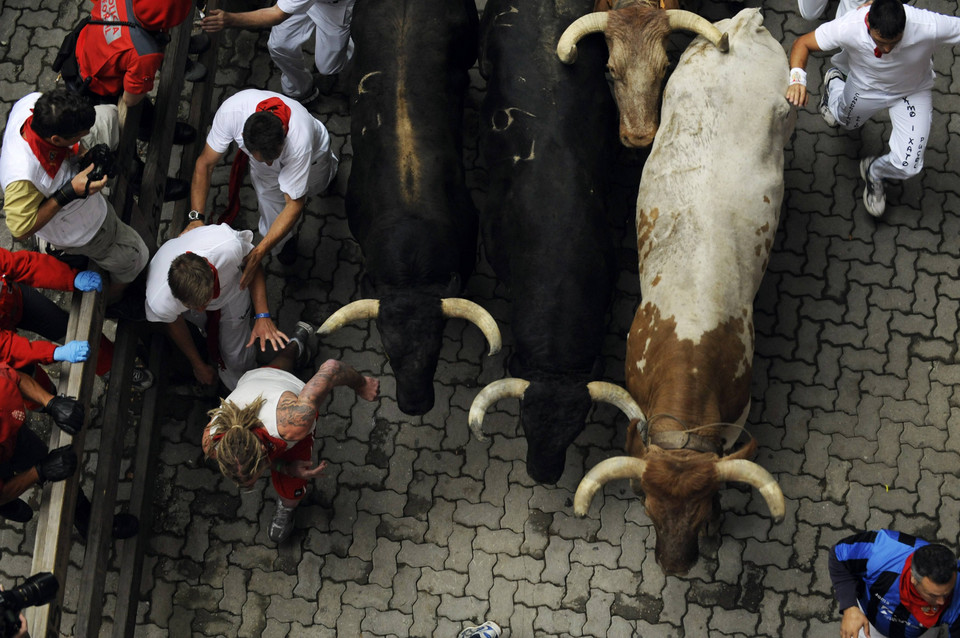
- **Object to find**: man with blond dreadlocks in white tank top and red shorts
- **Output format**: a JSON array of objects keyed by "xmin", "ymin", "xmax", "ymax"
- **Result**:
[{"xmin": 203, "ymin": 321, "xmax": 380, "ymax": 543}]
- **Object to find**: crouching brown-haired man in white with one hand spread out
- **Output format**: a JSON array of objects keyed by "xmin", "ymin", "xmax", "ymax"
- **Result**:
[{"xmin": 144, "ymin": 224, "xmax": 288, "ymax": 390}]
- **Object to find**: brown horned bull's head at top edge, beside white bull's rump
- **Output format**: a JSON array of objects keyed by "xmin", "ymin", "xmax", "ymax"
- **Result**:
[{"xmin": 557, "ymin": 0, "xmax": 728, "ymax": 148}]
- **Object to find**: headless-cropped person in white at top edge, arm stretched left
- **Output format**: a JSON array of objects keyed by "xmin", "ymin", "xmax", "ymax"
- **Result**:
[{"xmin": 201, "ymin": 0, "xmax": 356, "ymax": 104}]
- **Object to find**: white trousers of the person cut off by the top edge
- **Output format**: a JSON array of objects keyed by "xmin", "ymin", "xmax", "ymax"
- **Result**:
[{"xmin": 267, "ymin": 0, "xmax": 356, "ymax": 98}]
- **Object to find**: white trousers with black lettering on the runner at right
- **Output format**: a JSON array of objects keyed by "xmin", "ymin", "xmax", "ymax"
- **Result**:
[{"xmin": 829, "ymin": 78, "xmax": 933, "ymax": 185}]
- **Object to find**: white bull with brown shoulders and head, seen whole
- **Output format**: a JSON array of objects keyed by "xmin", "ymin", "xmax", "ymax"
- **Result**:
[{"xmin": 575, "ymin": 9, "xmax": 794, "ymax": 573}]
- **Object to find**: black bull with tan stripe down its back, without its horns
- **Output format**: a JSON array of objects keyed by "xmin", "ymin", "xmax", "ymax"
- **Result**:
[{"xmin": 346, "ymin": 0, "xmax": 478, "ymax": 415}]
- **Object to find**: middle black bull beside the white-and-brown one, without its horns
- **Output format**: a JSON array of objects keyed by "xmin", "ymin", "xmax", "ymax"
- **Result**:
[{"xmin": 480, "ymin": 0, "xmax": 617, "ymax": 483}]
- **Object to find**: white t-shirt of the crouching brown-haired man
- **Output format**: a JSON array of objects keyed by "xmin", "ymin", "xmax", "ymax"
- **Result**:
[{"xmin": 144, "ymin": 224, "xmax": 253, "ymax": 323}]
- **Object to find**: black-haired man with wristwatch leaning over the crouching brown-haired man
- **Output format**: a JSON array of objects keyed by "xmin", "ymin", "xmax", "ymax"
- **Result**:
[{"xmin": 187, "ymin": 89, "xmax": 339, "ymax": 287}]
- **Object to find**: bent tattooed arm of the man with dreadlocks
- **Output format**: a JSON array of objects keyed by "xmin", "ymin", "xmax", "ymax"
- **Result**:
[{"xmin": 277, "ymin": 359, "xmax": 380, "ymax": 441}]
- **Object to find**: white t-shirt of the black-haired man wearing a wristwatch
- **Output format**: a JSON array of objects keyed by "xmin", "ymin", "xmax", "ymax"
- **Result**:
[{"xmin": 207, "ymin": 89, "xmax": 330, "ymax": 199}]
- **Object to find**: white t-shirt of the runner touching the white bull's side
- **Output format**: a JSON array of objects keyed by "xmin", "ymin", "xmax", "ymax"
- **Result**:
[{"xmin": 815, "ymin": 5, "xmax": 960, "ymax": 96}]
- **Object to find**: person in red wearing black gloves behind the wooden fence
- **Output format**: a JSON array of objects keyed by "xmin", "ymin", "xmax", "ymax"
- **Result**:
[{"xmin": 0, "ymin": 365, "xmax": 139, "ymax": 544}]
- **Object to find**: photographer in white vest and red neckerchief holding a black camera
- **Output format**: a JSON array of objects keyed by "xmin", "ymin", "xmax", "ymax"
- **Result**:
[{"xmin": 0, "ymin": 89, "xmax": 149, "ymax": 304}]
